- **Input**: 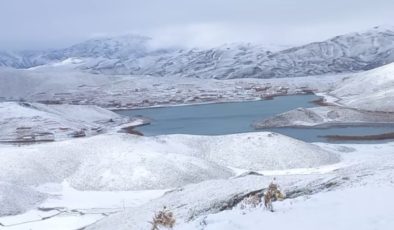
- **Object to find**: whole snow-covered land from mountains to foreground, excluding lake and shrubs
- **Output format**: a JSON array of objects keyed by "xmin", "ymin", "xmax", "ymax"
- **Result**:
[{"xmin": 0, "ymin": 24, "xmax": 394, "ymax": 230}]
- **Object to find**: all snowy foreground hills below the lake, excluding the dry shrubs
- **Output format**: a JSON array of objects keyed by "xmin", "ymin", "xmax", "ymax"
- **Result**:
[{"xmin": 0, "ymin": 130, "xmax": 394, "ymax": 229}]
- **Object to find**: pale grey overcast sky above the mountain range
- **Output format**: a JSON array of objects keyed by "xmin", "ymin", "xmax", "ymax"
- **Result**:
[{"xmin": 0, "ymin": 0, "xmax": 394, "ymax": 49}]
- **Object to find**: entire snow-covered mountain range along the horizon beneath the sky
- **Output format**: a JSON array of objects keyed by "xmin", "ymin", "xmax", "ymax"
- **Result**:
[{"xmin": 0, "ymin": 27, "xmax": 394, "ymax": 79}]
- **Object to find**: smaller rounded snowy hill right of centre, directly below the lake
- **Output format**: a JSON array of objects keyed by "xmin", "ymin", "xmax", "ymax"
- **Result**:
[{"xmin": 159, "ymin": 132, "xmax": 339, "ymax": 170}]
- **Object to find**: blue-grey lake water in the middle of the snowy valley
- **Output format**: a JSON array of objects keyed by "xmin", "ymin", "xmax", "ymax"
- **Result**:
[{"xmin": 117, "ymin": 95, "xmax": 394, "ymax": 142}]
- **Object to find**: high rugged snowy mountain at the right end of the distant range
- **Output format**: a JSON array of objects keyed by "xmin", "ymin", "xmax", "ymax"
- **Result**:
[{"xmin": 255, "ymin": 27, "xmax": 394, "ymax": 77}]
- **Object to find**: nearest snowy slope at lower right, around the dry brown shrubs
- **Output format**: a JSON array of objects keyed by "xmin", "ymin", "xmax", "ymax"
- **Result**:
[{"xmin": 87, "ymin": 143, "xmax": 394, "ymax": 230}]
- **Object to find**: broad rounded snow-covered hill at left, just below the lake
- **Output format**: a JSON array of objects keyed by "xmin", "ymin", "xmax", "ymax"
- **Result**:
[{"xmin": 0, "ymin": 134, "xmax": 232, "ymax": 190}]
